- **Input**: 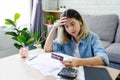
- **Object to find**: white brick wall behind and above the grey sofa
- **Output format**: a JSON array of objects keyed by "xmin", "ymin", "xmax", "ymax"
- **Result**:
[{"xmin": 43, "ymin": 0, "xmax": 120, "ymax": 16}]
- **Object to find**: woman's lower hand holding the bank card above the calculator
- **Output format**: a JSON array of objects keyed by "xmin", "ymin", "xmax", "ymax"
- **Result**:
[{"xmin": 61, "ymin": 58, "xmax": 80, "ymax": 68}]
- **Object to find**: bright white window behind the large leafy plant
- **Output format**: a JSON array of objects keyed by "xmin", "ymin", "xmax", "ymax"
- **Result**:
[{"xmin": 0, "ymin": 0, "xmax": 31, "ymax": 27}]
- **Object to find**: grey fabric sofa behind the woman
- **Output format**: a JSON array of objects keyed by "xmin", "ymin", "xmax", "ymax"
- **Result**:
[{"xmin": 82, "ymin": 14, "xmax": 120, "ymax": 69}]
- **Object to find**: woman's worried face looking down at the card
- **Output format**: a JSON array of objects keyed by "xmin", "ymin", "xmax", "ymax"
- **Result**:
[{"xmin": 65, "ymin": 18, "xmax": 81, "ymax": 37}]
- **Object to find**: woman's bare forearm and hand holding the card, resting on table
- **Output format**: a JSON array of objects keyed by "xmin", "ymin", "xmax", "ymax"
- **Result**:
[{"xmin": 61, "ymin": 56, "xmax": 105, "ymax": 67}]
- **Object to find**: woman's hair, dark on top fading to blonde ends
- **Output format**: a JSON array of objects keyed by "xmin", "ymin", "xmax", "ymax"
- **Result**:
[{"xmin": 57, "ymin": 9, "xmax": 89, "ymax": 44}]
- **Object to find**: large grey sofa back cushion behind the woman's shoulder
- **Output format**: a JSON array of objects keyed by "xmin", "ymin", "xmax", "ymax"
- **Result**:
[{"xmin": 83, "ymin": 14, "xmax": 119, "ymax": 42}]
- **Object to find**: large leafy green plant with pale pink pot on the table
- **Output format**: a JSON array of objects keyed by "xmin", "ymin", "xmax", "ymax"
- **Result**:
[{"xmin": 5, "ymin": 13, "xmax": 39, "ymax": 57}]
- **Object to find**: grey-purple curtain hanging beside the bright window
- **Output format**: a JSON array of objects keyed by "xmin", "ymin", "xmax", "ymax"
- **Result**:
[{"xmin": 30, "ymin": 0, "xmax": 43, "ymax": 35}]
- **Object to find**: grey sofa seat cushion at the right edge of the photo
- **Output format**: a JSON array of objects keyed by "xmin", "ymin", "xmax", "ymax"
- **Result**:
[{"xmin": 106, "ymin": 43, "xmax": 120, "ymax": 63}]
